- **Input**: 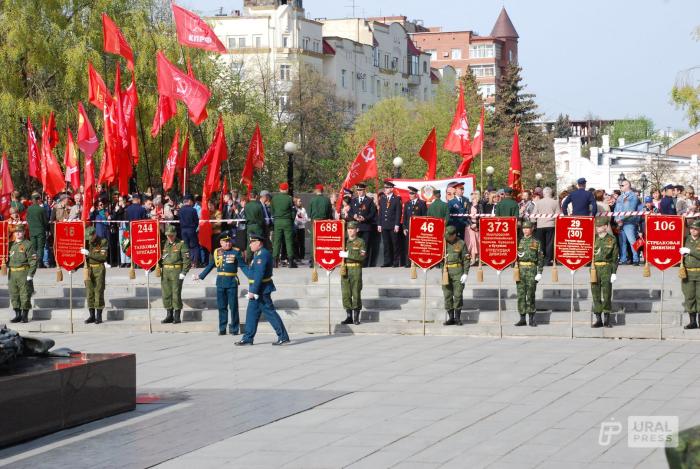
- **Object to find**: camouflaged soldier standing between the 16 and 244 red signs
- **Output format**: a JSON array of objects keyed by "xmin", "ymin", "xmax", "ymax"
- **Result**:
[{"xmin": 80, "ymin": 226, "xmax": 109, "ymax": 324}]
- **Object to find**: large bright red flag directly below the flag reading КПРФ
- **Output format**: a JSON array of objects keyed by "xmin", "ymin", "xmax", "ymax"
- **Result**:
[{"xmin": 157, "ymin": 51, "xmax": 211, "ymax": 124}]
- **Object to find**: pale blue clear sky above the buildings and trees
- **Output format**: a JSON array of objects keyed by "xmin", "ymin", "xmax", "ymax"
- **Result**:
[{"xmin": 179, "ymin": 0, "xmax": 700, "ymax": 130}]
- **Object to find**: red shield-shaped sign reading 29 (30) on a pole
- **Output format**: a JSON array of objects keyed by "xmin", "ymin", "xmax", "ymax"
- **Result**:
[{"xmin": 554, "ymin": 217, "xmax": 595, "ymax": 270}]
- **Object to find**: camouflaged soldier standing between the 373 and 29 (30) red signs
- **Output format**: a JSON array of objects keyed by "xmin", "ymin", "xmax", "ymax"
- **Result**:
[{"xmin": 515, "ymin": 220, "xmax": 544, "ymax": 327}]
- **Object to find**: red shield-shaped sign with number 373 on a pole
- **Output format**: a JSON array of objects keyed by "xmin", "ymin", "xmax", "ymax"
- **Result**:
[{"xmin": 479, "ymin": 217, "xmax": 518, "ymax": 270}]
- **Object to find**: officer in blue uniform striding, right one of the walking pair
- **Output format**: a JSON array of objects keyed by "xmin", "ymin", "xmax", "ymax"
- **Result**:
[{"xmin": 236, "ymin": 233, "xmax": 289, "ymax": 345}]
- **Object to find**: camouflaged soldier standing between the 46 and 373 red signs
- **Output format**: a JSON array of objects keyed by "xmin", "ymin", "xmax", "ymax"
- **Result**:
[{"xmin": 442, "ymin": 225, "xmax": 471, "ymax": 326}]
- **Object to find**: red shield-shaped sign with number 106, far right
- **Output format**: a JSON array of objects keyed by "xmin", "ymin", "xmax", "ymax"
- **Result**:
[{"xmin": 644, "ymin": 215, "xmax": 685, "ymax": 270}]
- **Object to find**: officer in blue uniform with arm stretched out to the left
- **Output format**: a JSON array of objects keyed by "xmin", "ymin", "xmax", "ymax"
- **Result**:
[{"xmin": 195, "ymin": 234, "xmax": 241, "ymax": 335}]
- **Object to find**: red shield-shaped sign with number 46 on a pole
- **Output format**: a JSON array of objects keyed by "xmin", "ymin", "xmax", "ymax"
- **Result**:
[{"xmin": 408, "ymin": 217, "xmax": 445, "ymax": 269}]
